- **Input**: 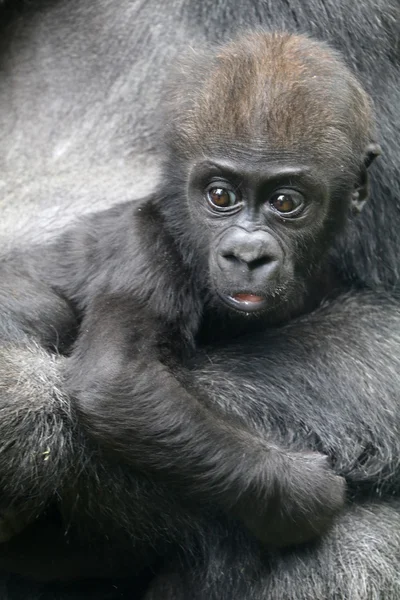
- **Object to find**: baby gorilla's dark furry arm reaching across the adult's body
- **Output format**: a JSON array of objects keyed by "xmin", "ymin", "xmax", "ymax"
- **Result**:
[{"xmin": 67, "ymin": 296, "xmax": 344, "ymax": 545}]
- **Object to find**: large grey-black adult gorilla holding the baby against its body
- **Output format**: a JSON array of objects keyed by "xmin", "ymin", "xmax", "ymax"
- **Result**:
[{"xmin": 0, "ymin": 0, "xmax": 400, "ymax": 600}]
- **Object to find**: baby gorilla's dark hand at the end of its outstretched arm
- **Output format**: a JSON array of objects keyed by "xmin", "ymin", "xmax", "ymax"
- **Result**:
[{"xmin": 237, "ymin": 450, "xmax": 346, "ymax": 546}]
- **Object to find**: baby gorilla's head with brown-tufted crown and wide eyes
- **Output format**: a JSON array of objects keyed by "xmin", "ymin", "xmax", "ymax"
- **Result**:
[{"xmin": 159, "ymin": 33, "xmax": 379, "ymax": 319}]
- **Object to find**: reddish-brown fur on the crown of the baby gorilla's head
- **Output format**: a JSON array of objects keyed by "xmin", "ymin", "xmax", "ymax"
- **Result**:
[{"xmin": 169, "ymin": 32, "xmax": 373, "ymax": 169}]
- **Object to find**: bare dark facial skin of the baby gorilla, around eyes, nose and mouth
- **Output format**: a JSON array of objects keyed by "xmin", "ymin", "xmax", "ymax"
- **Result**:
[{"xmin": 188, "ymin": 157, "xmax": 329, "ymax": 316}]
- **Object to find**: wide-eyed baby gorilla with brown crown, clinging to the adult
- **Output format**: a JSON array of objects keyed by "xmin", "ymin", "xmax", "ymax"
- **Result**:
[{"xmin": 40, "ymin": 33, "xmax": 379, "ymax": 545}]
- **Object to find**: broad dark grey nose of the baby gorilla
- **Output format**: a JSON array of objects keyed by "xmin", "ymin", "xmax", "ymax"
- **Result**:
[{"xmin": 219, "ymin": 230, "xmax": 281, "ymax": 271}]
